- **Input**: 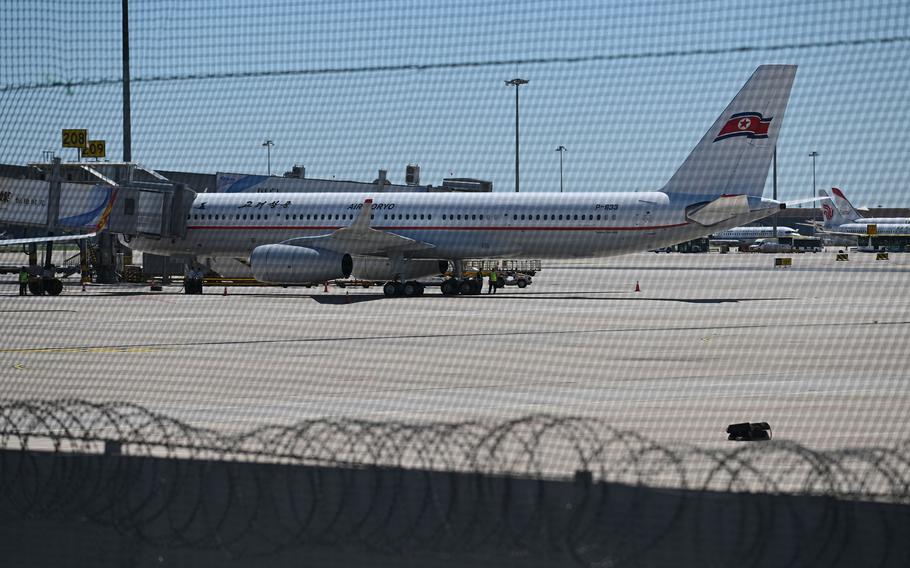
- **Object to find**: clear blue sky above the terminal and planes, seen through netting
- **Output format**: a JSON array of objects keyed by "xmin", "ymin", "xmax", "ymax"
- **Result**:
[{"xmin": 0, "ymin": 0, "xmax": 910, "ymax": 206}]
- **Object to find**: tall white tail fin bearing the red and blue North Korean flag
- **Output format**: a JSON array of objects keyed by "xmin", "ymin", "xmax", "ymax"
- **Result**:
[{"xmin": 661, "ymin": 65, "xmax": 796, "ymax": 201}]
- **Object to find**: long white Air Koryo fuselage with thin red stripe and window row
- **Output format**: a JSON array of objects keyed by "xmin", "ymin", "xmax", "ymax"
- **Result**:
[{"xmin": 128, "ymin": 192, "xmax": 776, "ymax": 259}]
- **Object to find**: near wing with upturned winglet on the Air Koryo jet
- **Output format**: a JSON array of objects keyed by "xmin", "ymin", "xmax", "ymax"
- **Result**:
[{"xmin": 281, "ymin": 199, "xmax": 435, "ymax": 255}]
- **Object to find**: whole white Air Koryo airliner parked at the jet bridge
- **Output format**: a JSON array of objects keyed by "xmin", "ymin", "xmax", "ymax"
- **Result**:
[{"xmin": 1, "ymin": 65, "xmax": 796, "ymax": 296}]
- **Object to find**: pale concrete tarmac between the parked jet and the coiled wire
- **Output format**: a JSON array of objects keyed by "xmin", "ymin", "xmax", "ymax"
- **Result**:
[{"xmin": 0, "ymin": 249, "xmax": 910, "ymax": 449}]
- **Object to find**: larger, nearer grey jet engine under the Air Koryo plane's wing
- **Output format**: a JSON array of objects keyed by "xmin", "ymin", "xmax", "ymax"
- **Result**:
[{"xmin": 250, "ymin": 245, "xmax": 354, "ymax": 284}]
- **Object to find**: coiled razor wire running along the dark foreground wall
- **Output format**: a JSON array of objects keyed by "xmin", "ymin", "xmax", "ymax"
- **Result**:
[{"xmin": 0, "ymin": 400, "xmax": 910, "ymax": 565}]
